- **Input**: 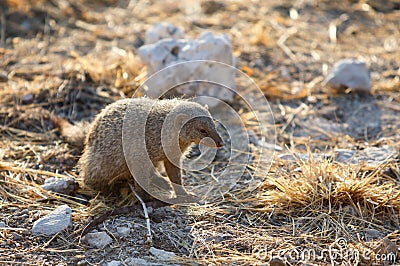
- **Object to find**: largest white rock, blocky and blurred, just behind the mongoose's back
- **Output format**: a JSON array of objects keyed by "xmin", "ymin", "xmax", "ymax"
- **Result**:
[{"xmin": 138, "ymin": 32, "xmax": 236, "ymax": 107}]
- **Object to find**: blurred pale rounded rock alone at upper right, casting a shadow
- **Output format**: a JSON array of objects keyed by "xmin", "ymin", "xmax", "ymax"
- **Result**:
[{"xmin": 324, "ymin": 59, "xmax": 372, "ymax": 92}]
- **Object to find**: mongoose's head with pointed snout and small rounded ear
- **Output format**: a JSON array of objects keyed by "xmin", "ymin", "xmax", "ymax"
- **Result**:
[{"xmin": 175, "ymin": 102, "xmax": 224, "ymax": 148}]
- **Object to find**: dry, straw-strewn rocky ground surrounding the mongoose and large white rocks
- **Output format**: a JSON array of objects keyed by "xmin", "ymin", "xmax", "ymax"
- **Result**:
[{"xmin": 0, "ymin": 0, "xmax": 400, "ymax": 265}]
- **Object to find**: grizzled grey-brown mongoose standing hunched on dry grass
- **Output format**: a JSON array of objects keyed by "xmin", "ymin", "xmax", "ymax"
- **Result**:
[{"xmin": 52, "ymin": 98, "xmax": 223, "ymax": 202}]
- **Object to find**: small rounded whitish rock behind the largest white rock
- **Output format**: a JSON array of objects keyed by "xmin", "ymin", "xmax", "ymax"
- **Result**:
[{"xmin": 145, "ymin": 22, "xmax": 185, "ymax": 44}]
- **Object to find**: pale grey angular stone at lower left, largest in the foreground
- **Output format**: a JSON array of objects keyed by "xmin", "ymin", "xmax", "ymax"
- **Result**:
[{"xmin": 32, "ymin": 205, "xmax": 72, "ymax": 236}]
